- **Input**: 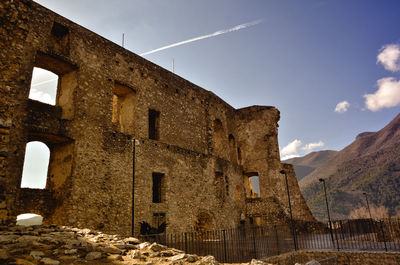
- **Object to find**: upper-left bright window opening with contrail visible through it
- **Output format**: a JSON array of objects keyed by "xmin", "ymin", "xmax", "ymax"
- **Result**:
[{"xmin": 29, "ymin": 67, "xmax": 58, "ymax": 106}]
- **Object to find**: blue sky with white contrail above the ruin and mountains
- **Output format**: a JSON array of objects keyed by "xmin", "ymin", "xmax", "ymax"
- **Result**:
[{"xmin": 32, "ymin": 0, "xmax": 400, "ymax": 157}]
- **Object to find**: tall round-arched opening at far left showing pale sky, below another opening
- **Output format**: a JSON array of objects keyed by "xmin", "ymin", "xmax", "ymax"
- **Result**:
[{"xmin": 21, "ymin": 141, "xmax": 50, "ymax": 189}]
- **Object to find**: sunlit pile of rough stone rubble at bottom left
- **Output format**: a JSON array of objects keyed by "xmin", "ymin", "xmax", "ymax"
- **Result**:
[{"xmin": 0, "ymin": 225, "xmax": 222, "ymax": 265}]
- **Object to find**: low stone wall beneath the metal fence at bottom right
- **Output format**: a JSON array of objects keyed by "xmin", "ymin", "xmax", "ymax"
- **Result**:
[{"xmin": 265, "ymin": 251, "xmax": 400, "ymax": 265}]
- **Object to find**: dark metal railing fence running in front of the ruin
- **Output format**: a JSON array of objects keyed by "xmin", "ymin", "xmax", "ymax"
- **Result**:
[{"xmin": 141, "ymin": 219, "xmax": 400, "ymax": 263}]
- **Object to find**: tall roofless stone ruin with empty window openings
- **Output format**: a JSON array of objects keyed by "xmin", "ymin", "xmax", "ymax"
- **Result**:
[{"xmin": 0, "ymin": 0, "xmax": 314, "ymax": 235}]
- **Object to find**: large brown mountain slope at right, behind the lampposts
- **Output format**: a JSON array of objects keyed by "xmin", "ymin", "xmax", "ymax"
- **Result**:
[{"xmin": 296, "ymin": 114, "xmax": 400, "ymax": 219}]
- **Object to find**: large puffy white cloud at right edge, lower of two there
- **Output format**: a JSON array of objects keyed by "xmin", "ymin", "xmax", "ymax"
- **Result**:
[{"xmin": 364, "ymin": 77, "xmax": 400, "ymax": 111}]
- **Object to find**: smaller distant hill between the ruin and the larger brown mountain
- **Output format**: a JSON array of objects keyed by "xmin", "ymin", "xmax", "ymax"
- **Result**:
[{"xmin": 283, "ymin": 150, "xmax": 337, "ymax": 181}]
